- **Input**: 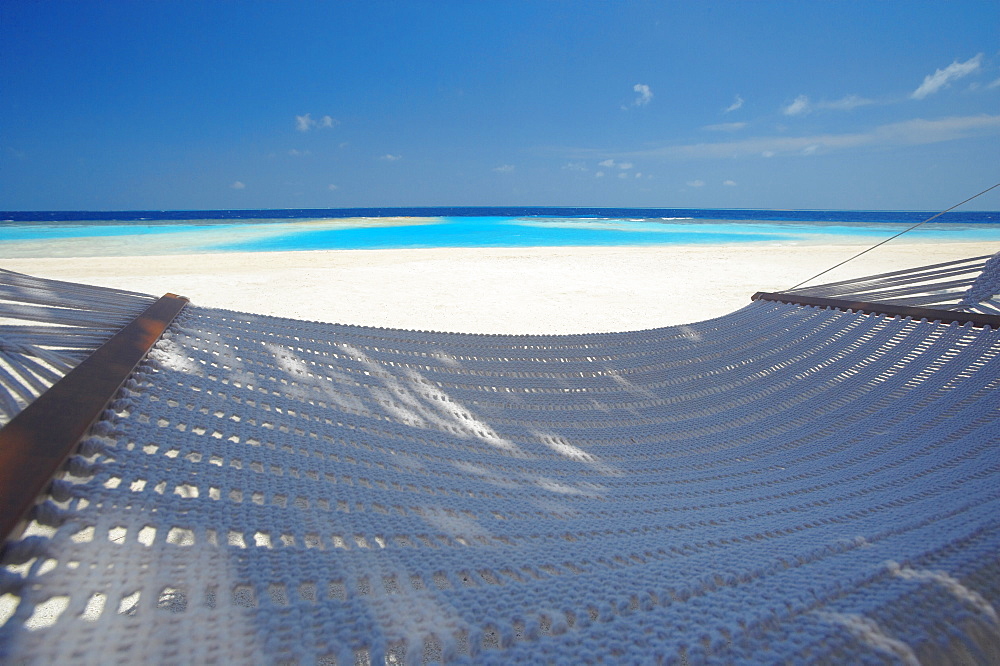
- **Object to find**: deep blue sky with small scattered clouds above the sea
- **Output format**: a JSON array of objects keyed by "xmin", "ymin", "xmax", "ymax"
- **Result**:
[{"xmin": 0, "ymin": 0, "xmax": 1000, "ymax": 210}]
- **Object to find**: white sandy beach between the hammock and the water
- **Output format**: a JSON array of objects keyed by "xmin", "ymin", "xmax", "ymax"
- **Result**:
[{"xmin": 0, "ymin": 241, "xmax": 1000, "ymax": 333}]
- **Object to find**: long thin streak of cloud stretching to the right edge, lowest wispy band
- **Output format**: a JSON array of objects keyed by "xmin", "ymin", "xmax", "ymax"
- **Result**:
[{"xmin": 602, "ymin": 114, "xmax": 1000, "ymax": 160}]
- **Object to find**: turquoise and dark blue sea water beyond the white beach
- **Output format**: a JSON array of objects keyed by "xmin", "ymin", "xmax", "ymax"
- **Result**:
[{"xmin": 0, "ymin": 208, "xmax": 1000, "ymax": 258}]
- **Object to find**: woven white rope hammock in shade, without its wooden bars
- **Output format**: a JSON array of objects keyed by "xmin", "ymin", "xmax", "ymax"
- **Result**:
[{"xmin": 0, "ymin": 257, "xmax": 1000, "ymax": 666}]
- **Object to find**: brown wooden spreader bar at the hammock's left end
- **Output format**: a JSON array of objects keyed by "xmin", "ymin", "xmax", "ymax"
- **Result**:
[{"xmin": 0, "ymin": 294, "xmax": 188, "ymax": 543}]
